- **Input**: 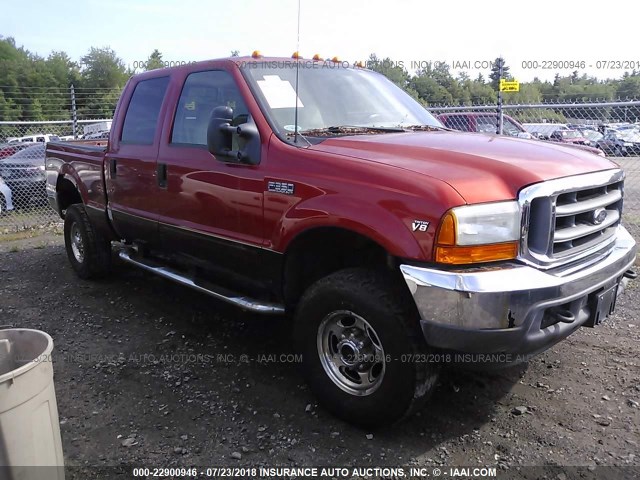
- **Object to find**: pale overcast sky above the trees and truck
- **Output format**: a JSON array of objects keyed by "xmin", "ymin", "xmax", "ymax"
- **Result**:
[{"xmin": 0, "ymin": 0, "xmax": 640, "ymax": 81}]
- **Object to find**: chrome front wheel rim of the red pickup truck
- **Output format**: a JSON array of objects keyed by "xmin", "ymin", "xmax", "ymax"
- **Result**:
[{"xmin": 317, "ymin": 310, "xmax": 386, "ymax": 396}]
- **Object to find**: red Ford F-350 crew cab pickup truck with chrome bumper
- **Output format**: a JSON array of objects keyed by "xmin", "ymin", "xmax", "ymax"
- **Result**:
[{"xmin": 46, "ymin": 57, "xmax": 636, "ymax": 425}]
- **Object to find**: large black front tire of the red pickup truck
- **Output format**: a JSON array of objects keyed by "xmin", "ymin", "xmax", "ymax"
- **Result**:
[{"xmin": 294, "ymin": 268, "xmax": 439, "ymax": 427}]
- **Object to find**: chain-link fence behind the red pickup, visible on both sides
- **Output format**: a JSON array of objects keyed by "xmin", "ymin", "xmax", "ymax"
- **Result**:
[{"xmin": 0, "ymin": 101, "xmax": 640, "ymax": 244}]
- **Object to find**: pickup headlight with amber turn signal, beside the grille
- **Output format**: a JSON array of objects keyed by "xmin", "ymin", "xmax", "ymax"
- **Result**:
[{"xmin": 435, "ymin": 201, "xmax": 520, "ymax": 265}]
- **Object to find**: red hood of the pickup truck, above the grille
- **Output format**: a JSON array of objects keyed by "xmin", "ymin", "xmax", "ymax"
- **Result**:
[{"xmin": 310, "ymin": 131, "xmax": 617, "ymax": 203}]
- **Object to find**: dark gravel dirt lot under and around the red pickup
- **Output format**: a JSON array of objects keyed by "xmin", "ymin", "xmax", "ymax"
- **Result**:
[{"xmin": 0, "ymin": 237, "xmax": 640, "ymax": 479}]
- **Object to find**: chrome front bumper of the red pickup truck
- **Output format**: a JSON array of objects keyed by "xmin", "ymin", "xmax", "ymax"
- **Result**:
[{"xmin": 400, "ymin": 227, "xmax": 637, "ymax": 355}]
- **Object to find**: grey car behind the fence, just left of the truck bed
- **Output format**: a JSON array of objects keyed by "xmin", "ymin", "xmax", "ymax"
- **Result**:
[{"xmin": 0, "ymin": 143, "xmax": 47, "ymax": 206}]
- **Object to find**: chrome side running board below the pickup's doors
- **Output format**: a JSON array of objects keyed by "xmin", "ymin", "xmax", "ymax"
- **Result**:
[{"xmin": 119, "ymin": 249, "xmax": 284, "ymax": 315}]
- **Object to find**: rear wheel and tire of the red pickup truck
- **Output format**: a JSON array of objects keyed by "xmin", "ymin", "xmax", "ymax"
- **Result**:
[{"xmin": 64, "ymin": 204, "xmax": 111, "ymax": 279}]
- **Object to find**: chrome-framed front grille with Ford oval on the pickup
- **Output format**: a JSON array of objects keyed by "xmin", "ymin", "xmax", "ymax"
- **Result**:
[{"xmin": 520, "ymin": 169, "xmax": 624, "ymax": 267}]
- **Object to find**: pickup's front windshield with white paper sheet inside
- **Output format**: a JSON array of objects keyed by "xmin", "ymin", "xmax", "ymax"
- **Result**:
[{"xmin": 242, "ymin": 61, "xmax": 442, "ymax": 136}]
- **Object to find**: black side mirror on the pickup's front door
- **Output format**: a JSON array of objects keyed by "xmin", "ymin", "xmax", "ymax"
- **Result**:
[{"xmin": 207, "ymin": 106, "xmax": 260, "ymax": 165}]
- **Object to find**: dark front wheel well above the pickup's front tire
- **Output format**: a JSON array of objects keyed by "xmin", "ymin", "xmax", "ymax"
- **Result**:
[{"xmin": 282, "ymin": 227, "xmax": 399, "ymax": 307}]
